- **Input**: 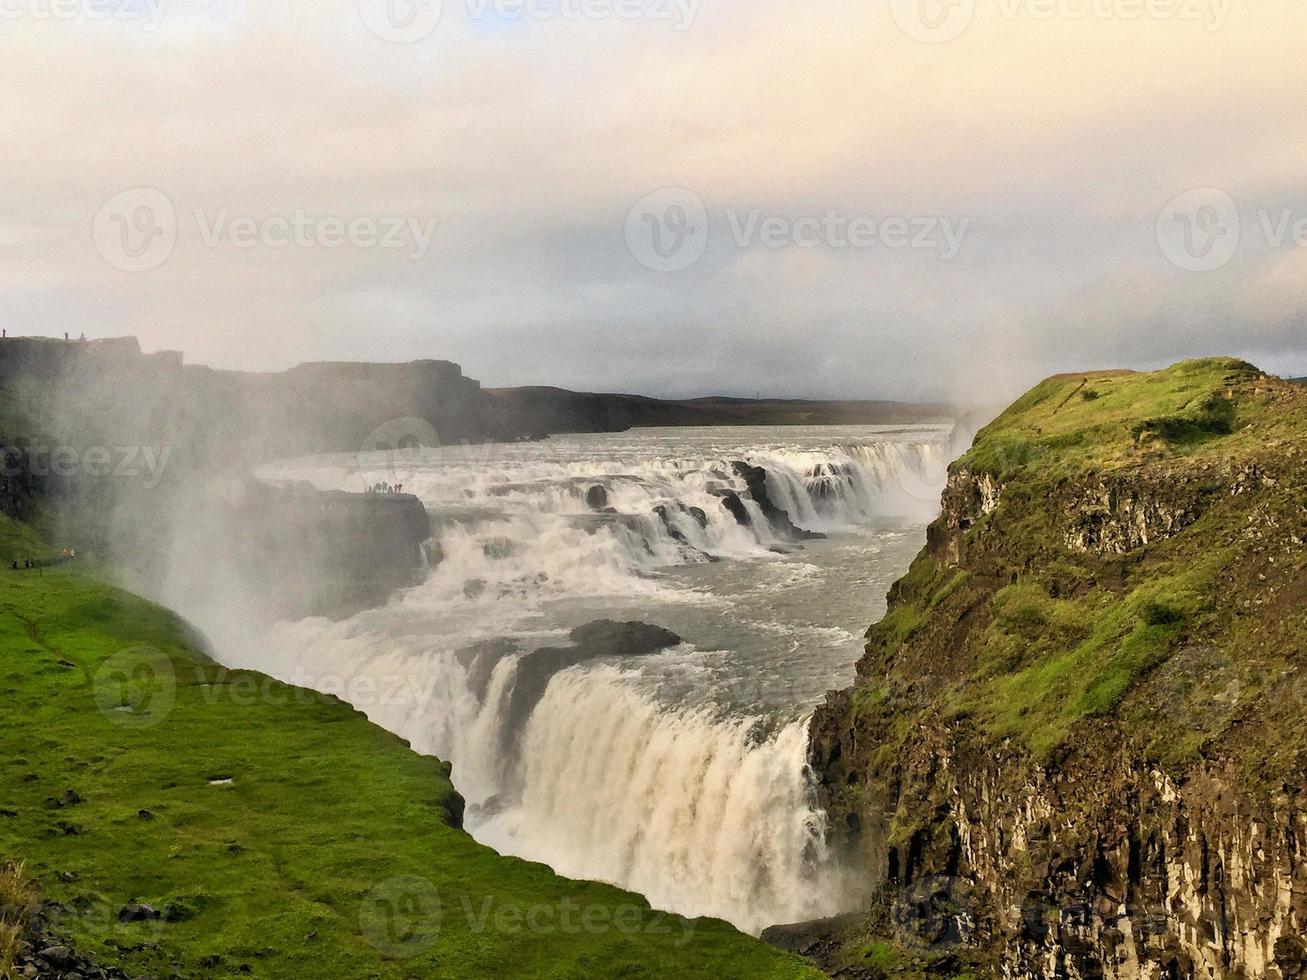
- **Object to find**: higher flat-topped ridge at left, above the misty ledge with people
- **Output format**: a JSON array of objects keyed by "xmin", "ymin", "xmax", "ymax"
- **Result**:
[{"xmin": 0, "ymin": 337, "xmax": 532, "ymax": 472}]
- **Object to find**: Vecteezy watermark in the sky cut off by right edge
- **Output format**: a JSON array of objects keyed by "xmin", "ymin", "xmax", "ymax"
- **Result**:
[{"xmin": 1157, "ymin": 187, "xmax": 1307, "ymax": 272}]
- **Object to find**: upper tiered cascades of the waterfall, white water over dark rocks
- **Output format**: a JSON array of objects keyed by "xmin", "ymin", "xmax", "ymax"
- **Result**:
[{"xmin": 269, "ymin": 430, "xmax": 950, "ymax": 604}]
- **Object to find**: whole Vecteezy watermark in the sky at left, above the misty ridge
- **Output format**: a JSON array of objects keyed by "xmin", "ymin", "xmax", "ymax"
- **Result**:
[{"xmin": 91, "ymin": 187, "xmax": 439, "ymax": 272}]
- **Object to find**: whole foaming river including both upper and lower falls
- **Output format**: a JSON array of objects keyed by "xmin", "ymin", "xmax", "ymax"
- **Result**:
[{"xmin": 243, "ymin": 426, "xmax": 954, "ymax": 932}]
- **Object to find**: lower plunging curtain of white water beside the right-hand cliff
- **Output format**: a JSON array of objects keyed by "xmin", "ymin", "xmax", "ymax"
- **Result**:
[{"xmin": 473, "ymin": 668, "xmax": 842, "ymax": 932}]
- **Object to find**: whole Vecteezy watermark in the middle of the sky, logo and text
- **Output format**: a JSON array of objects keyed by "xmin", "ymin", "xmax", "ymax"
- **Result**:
[{"xmin": 626, "ymin": 188, "xmax": 971, "ymax": 272}]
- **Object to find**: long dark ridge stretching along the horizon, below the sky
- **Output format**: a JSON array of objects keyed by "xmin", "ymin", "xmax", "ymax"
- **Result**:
[{"xmin": 0, "ymin": 337, "xmax": 957, "ymax": 449}]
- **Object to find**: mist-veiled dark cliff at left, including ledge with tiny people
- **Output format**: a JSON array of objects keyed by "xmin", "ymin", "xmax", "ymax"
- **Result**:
[{"xmin": 0, "ymin": 337, "xmax": 494, "ymax": 617}]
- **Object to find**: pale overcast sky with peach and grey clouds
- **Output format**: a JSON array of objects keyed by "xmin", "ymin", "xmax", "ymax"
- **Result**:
[{"xmin": 0, "ymin": 0, "xmax": 1307, "ymax": 399}]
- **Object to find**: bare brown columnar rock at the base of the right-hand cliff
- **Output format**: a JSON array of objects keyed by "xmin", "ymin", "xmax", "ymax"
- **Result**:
[{"xmin": 805, "ymin": 729, "xmax": 1307, "ymax": 980}]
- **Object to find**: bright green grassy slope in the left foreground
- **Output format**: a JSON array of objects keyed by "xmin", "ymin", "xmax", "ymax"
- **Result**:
[{"xmin": 0, "ymin": 519, "xmax": 814, "ymax": 977}]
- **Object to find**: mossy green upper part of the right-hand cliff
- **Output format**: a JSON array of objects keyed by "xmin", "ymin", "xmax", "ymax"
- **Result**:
[{"xmin": 860, "ymin": 359, "xmax": 1307, "ymax": 766}]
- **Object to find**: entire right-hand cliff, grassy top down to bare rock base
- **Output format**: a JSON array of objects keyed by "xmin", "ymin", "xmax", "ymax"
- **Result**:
[{"xmin": 771, "ymin": 361, "xmax": 1307, "ymax": 980}]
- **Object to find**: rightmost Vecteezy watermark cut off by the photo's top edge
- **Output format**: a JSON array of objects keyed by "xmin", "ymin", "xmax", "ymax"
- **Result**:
[{"xmin": 890, "ymin": 0, "xmax": 1235, "ymax": 44}]
